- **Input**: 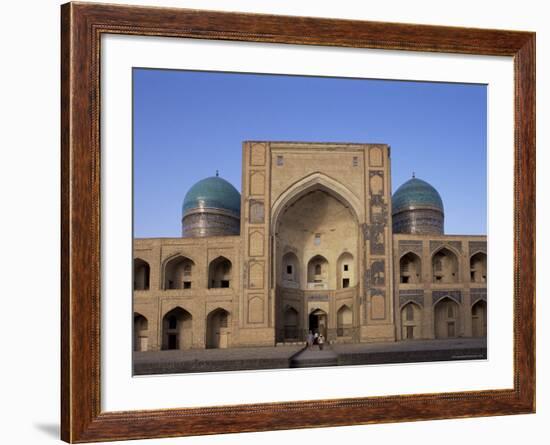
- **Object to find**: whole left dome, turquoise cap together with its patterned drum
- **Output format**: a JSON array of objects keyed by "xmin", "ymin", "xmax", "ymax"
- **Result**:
[{"xmin": 182, "ymin": 176, "xmax": 241, "ymax": 238}]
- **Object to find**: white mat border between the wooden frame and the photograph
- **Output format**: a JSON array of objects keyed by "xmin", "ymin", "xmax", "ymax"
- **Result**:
[{"xmin": 101, "ymin": 35, "xmax": 514, "ymax": 411}]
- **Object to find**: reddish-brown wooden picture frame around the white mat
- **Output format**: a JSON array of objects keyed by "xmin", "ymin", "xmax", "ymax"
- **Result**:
[{"xmin": 61, "ymin": 3, "xmax": 535, "ymax": 443}]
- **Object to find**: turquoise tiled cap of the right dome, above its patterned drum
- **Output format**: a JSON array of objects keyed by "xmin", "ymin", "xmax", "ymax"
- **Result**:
[{"xmin": 392, "ymin": 177, "xmax": 443, "ymax": 215}]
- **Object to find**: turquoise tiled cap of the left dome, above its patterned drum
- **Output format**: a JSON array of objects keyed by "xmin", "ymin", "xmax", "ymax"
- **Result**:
[{"xmin": 182, "ymin": 176, "xmax": 241, "ymax": 217}]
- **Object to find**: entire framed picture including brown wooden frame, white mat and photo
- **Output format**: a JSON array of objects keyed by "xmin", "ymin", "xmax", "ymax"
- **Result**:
[{"xmin": 61, "ymin": 3, "xmax": 535, "ymax": 443}]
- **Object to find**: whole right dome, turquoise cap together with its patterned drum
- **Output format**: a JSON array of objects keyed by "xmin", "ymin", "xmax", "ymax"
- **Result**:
[{"xmin": 392, "ymin": 177, "xmax": 445, "ymax": 235}]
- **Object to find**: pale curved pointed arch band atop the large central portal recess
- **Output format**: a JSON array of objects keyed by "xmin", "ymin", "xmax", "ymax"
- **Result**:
[{"xmin": 271, "ymin": 172, "xmax": 364, "ymax": 232}]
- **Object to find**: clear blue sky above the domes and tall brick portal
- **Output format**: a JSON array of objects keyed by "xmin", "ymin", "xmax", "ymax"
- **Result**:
[{"xmin": 133, "ymin": 69, "xmax": 487, "ymax": 238}]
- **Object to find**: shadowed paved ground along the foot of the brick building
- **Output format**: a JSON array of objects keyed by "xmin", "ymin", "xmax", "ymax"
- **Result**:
[{"xmin": 134, "ymin": 338, "xmax": 487, "ymax": 375}]
